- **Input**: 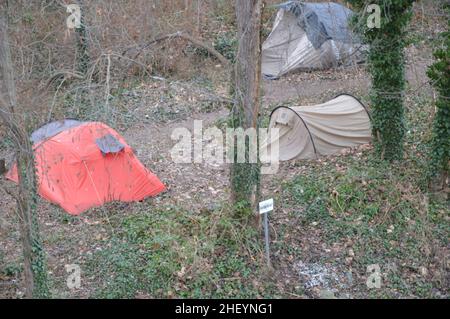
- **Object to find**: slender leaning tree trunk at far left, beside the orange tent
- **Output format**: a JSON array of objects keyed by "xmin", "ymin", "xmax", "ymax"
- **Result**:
[{"xmin": 0, "ymin": 16, "xmax": 49, "ymax": 298}]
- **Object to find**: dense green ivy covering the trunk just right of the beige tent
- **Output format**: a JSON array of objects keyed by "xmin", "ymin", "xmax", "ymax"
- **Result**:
[{"xmin": 348, "ymin": 0, "xmax": 414, "ymax": 161}]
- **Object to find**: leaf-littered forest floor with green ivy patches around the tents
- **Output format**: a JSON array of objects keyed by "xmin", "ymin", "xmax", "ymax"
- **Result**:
[{"xmin": 0, "ymin": 2, "xmax": 450, "ymax": 298}]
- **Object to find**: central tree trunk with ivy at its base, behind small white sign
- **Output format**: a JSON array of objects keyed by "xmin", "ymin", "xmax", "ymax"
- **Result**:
[{"xmin": 231, "ymin": 0, "xmax": 262, "ymax": 219}]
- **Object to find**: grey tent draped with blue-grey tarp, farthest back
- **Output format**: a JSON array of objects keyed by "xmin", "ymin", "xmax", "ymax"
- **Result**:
[{"xmin": 262, "ymin": 1, "xmax": 361, "ymax": 78}]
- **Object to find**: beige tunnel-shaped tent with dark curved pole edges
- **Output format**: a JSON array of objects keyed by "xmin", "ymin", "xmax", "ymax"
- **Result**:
[{"xmin": 261, "ymin": 94, "xmax": 371, "ymax": 161}]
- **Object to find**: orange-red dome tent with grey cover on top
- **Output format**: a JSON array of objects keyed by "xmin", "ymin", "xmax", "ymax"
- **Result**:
[{"xmin": 6, "ymin": 120, "xmax": 166, "ymax": 215}]
